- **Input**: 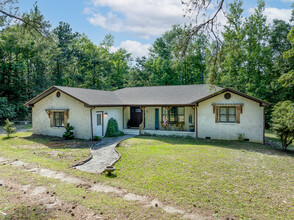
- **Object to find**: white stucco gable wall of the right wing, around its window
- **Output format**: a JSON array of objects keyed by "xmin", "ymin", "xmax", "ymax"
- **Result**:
[{"xmin": 197, "ymin": 93, "xmax": 264, "ymax": 143}]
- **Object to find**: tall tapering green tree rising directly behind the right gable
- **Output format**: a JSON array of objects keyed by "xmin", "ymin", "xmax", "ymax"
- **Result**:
[{"xmin": 207, "ymin": 0, "xmax": 247, "ymax": 91}]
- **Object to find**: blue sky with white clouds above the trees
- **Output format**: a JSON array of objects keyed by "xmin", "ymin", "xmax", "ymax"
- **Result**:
[{"xmin": 19, "ymin": 0, "xmax": 294, "ymax": 57}]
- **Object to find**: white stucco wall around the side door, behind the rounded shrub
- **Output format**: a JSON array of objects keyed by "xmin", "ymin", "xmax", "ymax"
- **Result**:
[{"xmin": 92, "ymin": 107, "xmax": 123, "ymax": 136}]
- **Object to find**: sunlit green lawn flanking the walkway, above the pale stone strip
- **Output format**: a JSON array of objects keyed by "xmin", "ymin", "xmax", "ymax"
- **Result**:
[{"xmin": 0, "ymin": 133, "xmax": 294, "ymax": 219}]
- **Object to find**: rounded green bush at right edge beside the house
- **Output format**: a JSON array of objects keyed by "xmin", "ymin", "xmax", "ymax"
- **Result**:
[{"xmin": 272, "ymin": 101, "xmax": 294, "ymax": 150}]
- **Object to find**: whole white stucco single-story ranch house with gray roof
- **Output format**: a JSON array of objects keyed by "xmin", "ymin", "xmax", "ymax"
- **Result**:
[{"xmin": 25, "ymin": 84, "xmax": 270, "ymax": 143}]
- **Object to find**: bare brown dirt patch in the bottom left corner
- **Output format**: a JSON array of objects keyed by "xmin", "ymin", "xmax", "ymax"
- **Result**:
[{"xmin": 1, "ymin": 179, "xmax": 100, "ymax": 219}]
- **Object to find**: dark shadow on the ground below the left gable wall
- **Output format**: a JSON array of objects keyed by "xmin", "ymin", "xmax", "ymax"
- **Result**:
[{"xmin": 19, "ymin": 134, "xmax": 96, "ymax": 149}]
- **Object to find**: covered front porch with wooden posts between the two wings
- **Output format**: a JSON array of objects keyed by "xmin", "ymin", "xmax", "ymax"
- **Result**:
[{"xmin": 123, "ymin": 105, "xmax": 197, "ymax": 137}]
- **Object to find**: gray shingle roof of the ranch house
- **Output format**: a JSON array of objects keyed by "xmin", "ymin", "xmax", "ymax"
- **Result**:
[{"xmin": 25, "ymin": 84, "xmax": 272, "ymax": 106}]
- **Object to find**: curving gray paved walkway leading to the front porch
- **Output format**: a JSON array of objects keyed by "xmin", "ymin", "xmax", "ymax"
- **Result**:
[{"xmin": 76, "ymin": 135, "xmax": 135, "ymax": 173}]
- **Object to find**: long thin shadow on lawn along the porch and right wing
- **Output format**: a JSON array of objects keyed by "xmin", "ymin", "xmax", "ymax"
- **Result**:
[{"xmin": 136, "ymin": 136, "xmax": 294, "ymax": 157}]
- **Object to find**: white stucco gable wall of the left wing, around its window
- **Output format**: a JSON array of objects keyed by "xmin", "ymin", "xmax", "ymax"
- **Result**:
[{"xmin": 32, "ymin": 91, "xmax": 91, "ymax": 139}]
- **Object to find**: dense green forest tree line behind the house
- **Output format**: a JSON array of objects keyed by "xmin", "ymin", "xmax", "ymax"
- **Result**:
[{"xmin": 0, "ymin": 0, "xmax": 294, "ymax": 125}]
